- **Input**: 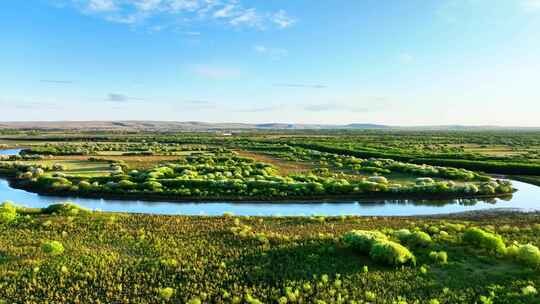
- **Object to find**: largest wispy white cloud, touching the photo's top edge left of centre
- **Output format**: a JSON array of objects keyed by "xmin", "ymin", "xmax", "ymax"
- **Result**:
[{"xmin": 58, "ymin": 0, "xmax": 296, "ymax": 29}]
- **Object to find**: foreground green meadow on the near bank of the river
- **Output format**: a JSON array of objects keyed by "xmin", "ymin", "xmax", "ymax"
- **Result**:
[{"xmin": 0, "ymin": 206, "xmax": 540, "ymax": 303}]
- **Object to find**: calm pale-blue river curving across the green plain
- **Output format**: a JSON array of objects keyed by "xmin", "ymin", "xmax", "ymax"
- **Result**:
[{"xmin": 0, "ymin": 149, "xmax": 540, "ymax": 216}]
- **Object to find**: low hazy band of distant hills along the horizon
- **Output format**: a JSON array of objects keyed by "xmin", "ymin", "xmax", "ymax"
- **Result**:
[{"xmin": 0, "ymin": 120, "xmax": 540, "ymax": 132}]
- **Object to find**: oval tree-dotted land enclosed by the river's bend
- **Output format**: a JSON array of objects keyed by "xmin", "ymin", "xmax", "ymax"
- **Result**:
[{"xmin": 0, "ymin": 135, "xmax": 514, "ymax": 202}]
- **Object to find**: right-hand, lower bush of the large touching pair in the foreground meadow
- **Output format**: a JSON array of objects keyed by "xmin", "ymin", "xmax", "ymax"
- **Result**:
[{"xmin": 369, "ymin": 240, "xmax": 416, "ymax": 266}]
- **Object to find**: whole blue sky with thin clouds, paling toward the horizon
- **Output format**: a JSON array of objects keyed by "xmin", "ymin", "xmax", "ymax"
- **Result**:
[{"xmin": 0, "ymin": 0, "xmax": 540, "ymax": 126}]
